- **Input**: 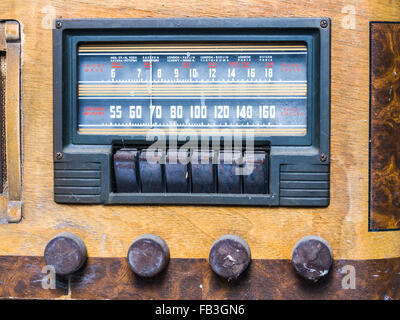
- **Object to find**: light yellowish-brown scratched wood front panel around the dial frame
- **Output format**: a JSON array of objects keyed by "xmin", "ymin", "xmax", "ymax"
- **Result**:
[{"xmin": 0, "ymin": 0, "xmax": 400, "ymax": 259}]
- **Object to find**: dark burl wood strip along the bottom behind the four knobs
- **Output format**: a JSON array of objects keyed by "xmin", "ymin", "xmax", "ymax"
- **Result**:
[{"xmin": 0, "ymin": 256, "xmax": 400, "ymax": 300}]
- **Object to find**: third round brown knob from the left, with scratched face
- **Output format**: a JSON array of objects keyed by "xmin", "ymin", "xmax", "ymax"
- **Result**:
[{"xmin": 209, "ymin": 235, "xmax": 251, "ymax": 280}]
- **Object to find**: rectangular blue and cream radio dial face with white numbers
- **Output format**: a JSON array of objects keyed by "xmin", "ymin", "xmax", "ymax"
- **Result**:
[{"xmin": 78, "ymin": 43, "xmax": 307, "ymax": 137}]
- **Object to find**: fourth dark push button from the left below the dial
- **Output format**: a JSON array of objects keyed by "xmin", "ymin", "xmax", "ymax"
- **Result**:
[{"xmin": 192, "ymin": 150, "xmax": 216, "ymax": 193}]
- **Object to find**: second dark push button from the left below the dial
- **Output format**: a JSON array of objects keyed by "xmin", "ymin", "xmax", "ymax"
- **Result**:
[{"xmin": 139, "ymin": 149, "xmax": 165, "ymax": 193}]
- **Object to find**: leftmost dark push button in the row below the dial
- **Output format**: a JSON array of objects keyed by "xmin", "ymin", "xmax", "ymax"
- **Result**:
[{"xmin": 114, "ymin": 149, "xmax": 139, "ymax": 192}]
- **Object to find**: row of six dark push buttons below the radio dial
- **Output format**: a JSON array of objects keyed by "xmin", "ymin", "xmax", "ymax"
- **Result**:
[{"xmin": 114, "ymin": 149, "xmax": 268, "ymax": 194}]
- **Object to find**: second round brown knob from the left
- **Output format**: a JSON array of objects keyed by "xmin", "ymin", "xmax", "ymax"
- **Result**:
[{"xmin": 128, "ymin": 234, "xmax": 169, "ymax": 277}]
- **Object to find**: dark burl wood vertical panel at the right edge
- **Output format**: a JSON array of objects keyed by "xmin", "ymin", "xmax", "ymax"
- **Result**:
[{"xmin": 370, "ymin": 23, "xmax": 400, "ymax": 230}]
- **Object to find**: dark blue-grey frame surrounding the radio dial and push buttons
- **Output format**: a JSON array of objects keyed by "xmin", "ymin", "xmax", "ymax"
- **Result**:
[{"xmin": 53, "ymin": 18, "xmax": 330, "ymax": 206}]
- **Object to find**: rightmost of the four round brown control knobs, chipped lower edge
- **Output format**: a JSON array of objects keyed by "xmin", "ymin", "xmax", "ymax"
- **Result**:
[{"xmin": 292, "ymin": 236, "xmax": 333, "ymax": 282}]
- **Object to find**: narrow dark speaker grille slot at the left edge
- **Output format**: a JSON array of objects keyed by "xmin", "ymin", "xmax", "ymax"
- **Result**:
[{"xmin": 0, "ymin": 52, "xmax": 7, "ymax": 193}]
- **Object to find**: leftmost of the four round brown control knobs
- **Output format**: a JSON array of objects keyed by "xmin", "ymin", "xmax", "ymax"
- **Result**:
[{"xmin": 44, "ymin": 232, "xmax": 87, "ymax": 276}]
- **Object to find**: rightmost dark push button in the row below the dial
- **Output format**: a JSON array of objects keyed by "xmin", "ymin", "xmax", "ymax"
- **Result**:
[{"xmin": 243, "ymin": 151, "xmax": 268, "ymax": 194}]
